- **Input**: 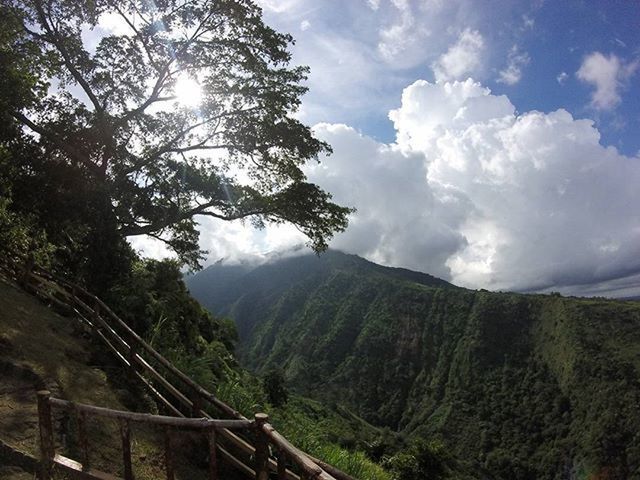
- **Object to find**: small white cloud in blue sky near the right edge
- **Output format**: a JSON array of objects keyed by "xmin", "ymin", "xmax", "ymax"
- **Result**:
[{"xmin": 576, "ymin": 52, "xmax": 639, "ymax": 110}]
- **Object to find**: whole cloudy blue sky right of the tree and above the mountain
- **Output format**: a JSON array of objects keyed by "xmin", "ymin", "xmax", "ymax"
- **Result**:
[{"xmin": 129, "ymin": 0, "xmax": 640, "ymax": 296}]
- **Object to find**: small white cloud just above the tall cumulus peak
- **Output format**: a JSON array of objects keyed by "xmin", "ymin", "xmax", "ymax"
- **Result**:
[{"xmin": 431, "ymin": 28, "xmax": 485, "ymax": 82}]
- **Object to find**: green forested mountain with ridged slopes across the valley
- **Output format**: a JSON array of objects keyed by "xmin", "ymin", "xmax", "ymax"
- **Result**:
[{"xmin": 188, "ymin": 252, "xmax": 640, "ymax": 479}]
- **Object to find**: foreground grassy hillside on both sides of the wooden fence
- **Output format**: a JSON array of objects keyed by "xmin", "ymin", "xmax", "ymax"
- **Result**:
[{"xmin": 0, "ymin": 266, "xmax": 390, "ymax": 480}]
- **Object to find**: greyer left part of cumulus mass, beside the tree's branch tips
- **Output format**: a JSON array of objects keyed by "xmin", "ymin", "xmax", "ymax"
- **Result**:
[{"xmin": 308, "ymin": 124, "xmax": 470, "ymax": 277}]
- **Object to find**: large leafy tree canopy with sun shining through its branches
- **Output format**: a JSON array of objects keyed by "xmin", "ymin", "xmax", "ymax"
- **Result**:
[{"xmin": 0, "ymin": 0, "xmax": 350, "ymax": 265}]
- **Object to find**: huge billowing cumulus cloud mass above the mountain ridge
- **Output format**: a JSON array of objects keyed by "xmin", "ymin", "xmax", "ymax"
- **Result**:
[{"xmin": 309, "ymin": 80, "xmax": 640, "ymax": 290}]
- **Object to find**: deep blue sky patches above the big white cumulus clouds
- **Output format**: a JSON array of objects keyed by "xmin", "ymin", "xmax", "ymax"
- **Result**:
[{"xmin": 261, "ymin": 0, "xmax": 640, "ymax": 155}]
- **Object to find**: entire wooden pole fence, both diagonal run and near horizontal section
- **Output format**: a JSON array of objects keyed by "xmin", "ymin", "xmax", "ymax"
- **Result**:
[{"xmin": 0, "ymin": 256, "xmax": 355, "ymax": 480}]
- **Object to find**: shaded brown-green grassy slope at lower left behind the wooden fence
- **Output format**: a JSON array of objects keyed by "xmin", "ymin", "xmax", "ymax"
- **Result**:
[{"xmin": 0, "ymin": 276, "xmax": 216, "ymax": 480}]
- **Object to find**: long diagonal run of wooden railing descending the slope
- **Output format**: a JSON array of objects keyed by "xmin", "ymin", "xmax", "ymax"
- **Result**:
[{"xmin": 1, "ymin": 258, "xmax": 355, "ymax": 480}]
